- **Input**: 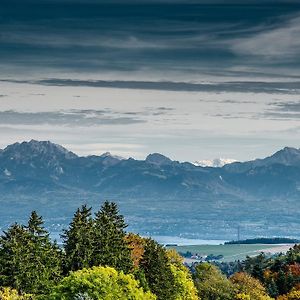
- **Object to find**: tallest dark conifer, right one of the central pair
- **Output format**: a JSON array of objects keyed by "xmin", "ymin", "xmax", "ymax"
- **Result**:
[{"xmin": 93, "ymin": 201, "xmax": 133, "ymax": 273}]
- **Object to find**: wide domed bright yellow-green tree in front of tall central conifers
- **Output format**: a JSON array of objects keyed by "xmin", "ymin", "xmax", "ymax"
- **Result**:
[{"xmin": 45, "ymin": 267, "xmax": 156, "ymax": 300}]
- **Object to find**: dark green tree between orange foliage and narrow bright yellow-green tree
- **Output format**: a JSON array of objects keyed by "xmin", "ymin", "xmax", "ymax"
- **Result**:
[{"xmin": 140, "ymin": 239, "xmax": 176, "ymax": 300}]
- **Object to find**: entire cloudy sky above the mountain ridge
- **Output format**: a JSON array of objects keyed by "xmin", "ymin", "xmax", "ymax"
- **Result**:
[{"xmin": 0, "ymin": 0, "xmax": 300, "ymax": 161}]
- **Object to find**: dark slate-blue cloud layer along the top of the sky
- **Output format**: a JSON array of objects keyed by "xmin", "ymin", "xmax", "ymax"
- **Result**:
[{"xmin": 0, "ymin": 0, "xmax": 300, "ymax": 77}]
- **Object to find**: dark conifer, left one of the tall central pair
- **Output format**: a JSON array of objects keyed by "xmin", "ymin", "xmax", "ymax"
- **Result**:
[{"xmin": 62, "ymin": 205, "xmax": 93, "ymax": 272}]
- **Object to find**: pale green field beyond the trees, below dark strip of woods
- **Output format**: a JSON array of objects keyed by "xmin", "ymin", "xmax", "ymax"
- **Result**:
[{"xmin": 169, "ymin": 244, "xmax": 292, "ymax": 261}]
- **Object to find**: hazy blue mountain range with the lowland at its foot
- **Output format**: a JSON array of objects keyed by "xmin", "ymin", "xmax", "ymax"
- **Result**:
[{"xmin": 0, "ymin": 140, "xmax": 300, "ymax": 239}]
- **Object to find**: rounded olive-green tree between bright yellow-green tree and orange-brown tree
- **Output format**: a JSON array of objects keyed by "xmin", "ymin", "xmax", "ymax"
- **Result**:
[{"xmin": 194, "ymin": 263, "xmax": 235, "ymax": 300}]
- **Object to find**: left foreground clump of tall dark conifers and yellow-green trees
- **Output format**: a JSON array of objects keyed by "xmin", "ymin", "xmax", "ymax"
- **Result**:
[{"xmin": 0, "ymin": 202, "xmax": 198, "ymax": 300}]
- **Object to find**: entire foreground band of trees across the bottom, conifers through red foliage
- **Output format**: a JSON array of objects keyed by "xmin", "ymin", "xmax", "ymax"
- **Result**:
[{"xmin": 0, "ymin": 202, "xmax": 300, "ymax": 300}]
